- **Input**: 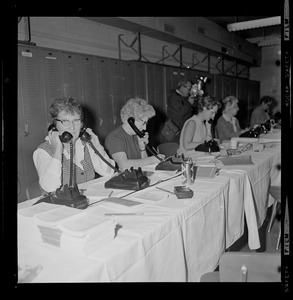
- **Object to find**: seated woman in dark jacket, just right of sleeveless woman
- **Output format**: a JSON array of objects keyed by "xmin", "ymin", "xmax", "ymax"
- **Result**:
[{"xmin": 216, "ymin": 96, "xmax": 248, "ymax": 141}]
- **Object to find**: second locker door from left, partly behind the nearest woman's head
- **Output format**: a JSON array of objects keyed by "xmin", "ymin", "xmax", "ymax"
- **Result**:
[{"xmin": 39, "ymin": 49, "xmax": 63, "ymax": 125}]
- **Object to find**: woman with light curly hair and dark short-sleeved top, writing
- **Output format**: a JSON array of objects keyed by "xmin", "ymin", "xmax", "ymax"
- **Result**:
[{"xmin": 105, "ymin": 98, "xmax": 164, "ymax": 170}]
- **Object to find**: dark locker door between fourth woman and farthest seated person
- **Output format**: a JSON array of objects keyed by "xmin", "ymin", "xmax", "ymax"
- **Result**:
[{"xmin": 236, "ymin": 78, "xmax": 250, "ymax": 128}]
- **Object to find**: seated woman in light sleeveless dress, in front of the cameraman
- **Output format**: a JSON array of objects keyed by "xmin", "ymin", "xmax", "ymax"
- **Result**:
[{"xmin": 177, "ymin": 96, "xmax": 219, "ymax": 154}]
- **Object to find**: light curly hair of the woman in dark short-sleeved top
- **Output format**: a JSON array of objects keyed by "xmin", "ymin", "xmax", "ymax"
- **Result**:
[{"xmin": 120, "ymin": 98, "xmax": 156, "ymax": 123}]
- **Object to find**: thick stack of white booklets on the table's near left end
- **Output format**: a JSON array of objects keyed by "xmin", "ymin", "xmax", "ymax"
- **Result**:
[{"xmin": 34, "ymin": 207, "xmax": 116, "ymax": 256}]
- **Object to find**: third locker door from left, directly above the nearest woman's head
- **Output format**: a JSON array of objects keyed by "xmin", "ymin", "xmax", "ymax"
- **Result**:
[{"xmin": 61, "ymin": 52, "xmax": 83, "ymax": 102}]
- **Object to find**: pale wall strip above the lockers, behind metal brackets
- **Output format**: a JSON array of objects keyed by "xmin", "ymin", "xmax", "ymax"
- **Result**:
[{"xmin": 18, "ymin": 17, "xmax": 247, "ymax": 77}]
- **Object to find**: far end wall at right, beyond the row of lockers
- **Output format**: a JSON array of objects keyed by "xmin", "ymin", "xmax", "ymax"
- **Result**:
[{"xmin": 250, "ymin": 45, "xmax": 281, "ymax": 112}]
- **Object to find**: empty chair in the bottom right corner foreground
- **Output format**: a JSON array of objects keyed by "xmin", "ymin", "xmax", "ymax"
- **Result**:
[{"xmin": 200, "ymin": 252, "xmax": 281, "ymax": 282}]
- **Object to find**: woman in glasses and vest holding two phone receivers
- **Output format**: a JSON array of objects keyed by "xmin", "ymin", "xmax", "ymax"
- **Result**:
[{"xmin": 33, "ymin": 98, "xmax": 115, "ymax": 193}]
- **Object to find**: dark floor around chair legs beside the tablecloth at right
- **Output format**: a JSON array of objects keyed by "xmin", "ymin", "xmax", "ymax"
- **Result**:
[{"xmin": 227, "ymin": 206, "xmax": 281, "ymax": 253}]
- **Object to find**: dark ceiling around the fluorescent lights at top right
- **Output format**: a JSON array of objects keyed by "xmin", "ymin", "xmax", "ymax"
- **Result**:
[{"xmin": 205, "ymin": 16, "xmax": 281, "ymax": 44}]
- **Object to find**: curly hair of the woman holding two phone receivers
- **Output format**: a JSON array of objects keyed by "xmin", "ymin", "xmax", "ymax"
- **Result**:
[{"xmin": 49, "ymin": 97, "xmax": 83, "ymax": 120}]
